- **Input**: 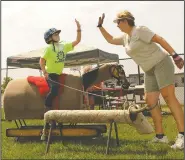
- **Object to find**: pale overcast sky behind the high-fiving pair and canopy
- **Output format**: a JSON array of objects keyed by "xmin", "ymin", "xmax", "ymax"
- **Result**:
[{"xmin": 1, "ymin": 1, "xmax": 184, "ymax": 79}]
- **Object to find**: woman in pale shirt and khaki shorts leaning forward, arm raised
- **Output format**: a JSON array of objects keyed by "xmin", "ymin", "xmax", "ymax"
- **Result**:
[{"xmin": 97, "ymin": 11, "xmax": 184, "ymax": 149}]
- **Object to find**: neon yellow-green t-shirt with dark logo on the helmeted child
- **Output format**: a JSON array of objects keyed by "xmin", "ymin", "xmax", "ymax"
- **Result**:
[{"xmin": 41, "ymin": 42, "xmax": 73, "ymax": 75}]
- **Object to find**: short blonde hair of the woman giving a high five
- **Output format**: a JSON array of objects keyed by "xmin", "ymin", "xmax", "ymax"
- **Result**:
[{"xmin": 117, "ymin": 10, "xmax": 135, "ymax": 26}]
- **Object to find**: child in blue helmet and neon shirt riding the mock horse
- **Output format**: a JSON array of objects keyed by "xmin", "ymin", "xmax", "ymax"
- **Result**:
[{"xmin": 40, "ymin": 19, "xmax": 81, "ymax": 112}]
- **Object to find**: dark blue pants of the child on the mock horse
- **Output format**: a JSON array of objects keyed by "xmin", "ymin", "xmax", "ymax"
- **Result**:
[{"xmin": 45, "ymin": 73, "xmax": 60, "ymax": 109}]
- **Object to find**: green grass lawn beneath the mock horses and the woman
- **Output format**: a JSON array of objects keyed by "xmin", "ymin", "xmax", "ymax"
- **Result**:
[{"xmin": 1, "ymin": 107, "xmax": 184, "ymax": 159}]
